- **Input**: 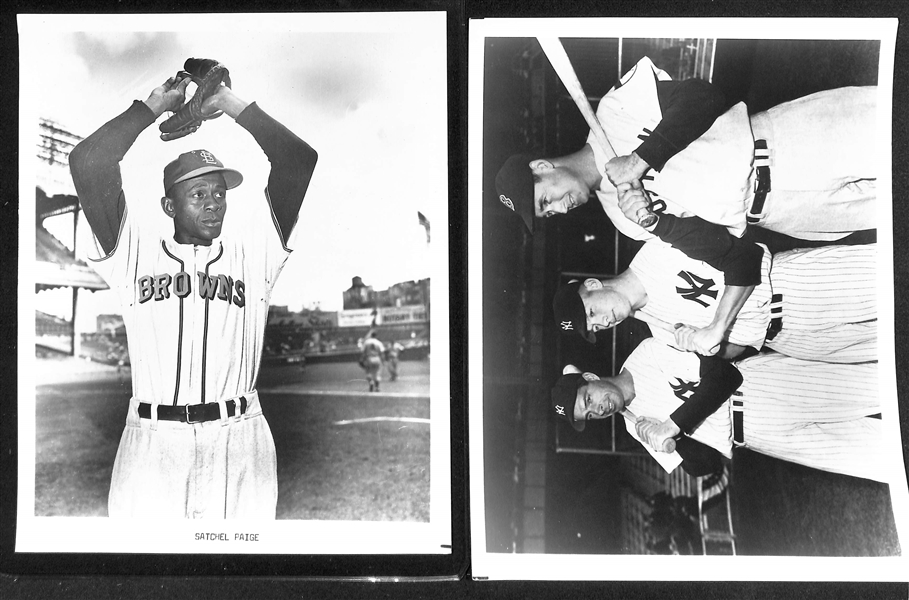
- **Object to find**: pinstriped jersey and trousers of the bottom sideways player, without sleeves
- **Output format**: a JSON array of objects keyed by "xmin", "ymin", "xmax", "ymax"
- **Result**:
[{"xmin": 623, "ymin": 338, "xmax": 887, "ymax": 481}]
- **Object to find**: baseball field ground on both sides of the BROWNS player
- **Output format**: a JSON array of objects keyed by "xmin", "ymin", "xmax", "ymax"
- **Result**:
[{"xmin": 35, "ymin": 359, "xmax": 430, "ymax": 522}]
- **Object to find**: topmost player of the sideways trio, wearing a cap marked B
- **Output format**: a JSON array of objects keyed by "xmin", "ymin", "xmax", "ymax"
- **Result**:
[{"xmin": 496, "ymin": 57, "xmax": 877, "ymax": 241}]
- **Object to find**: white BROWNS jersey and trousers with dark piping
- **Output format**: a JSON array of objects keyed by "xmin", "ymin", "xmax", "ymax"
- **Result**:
[{"xmin": 88, "ymin": 203, "xmax": 290, "ymax": 519}]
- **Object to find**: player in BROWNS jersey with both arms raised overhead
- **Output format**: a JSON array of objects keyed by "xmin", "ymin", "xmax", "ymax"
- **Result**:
[{"xmin": 70, "ymin": 59, "xmax": 317, "ymax": 519}]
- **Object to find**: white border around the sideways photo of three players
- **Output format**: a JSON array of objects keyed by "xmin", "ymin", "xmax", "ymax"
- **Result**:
[{"xmin": 467, "ymin": 18, "xmax": 909, "ymax": 582}]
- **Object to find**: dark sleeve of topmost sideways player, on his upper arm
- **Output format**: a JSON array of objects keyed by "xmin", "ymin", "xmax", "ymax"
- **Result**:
[{"xmin": 635, "ymin": 79, "xmax": 726, "ymax": 171}]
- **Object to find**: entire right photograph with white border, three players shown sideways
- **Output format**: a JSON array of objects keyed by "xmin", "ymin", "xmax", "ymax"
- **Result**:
[{"xmin": 468, "ymin": 18, "xmax": 909, "ymax": 581}]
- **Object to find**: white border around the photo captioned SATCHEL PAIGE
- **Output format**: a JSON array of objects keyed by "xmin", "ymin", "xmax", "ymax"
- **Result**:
[{"xmin": 15, "ymin": 11, "xmax": 450, "ymax": 556}]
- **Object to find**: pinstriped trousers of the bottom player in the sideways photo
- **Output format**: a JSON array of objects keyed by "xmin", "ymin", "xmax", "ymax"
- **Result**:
[{"xmin": 732, "ymin": 353, "xmax": 887, "ymax": 482}]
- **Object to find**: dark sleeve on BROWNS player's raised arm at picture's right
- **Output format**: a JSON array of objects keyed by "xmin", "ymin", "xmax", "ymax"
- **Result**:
[{"xmin": 237, "ymin": 102, "xmax": 319, "ymax": 246}]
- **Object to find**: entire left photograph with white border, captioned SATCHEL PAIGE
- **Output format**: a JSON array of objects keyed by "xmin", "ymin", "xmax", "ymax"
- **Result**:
[{"xmin": 16, "ymin": 11, "xmax": 452, "ymax": 554}]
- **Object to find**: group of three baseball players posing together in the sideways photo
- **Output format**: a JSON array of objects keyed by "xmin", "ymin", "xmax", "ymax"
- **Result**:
[{"xmin": 510, "ymin": 58, "xmax": 885, "ymax": 488}]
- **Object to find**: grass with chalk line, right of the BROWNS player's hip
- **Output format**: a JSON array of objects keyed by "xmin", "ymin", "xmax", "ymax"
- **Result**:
[{"xmin": 263, "ymin": 393, "xmax": 429, "ymax": 522}]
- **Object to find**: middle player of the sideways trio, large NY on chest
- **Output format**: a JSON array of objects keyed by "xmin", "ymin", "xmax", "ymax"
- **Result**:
[{"xmin": 553, "ymin": 178, "xmax": 877, "ymax": 363}]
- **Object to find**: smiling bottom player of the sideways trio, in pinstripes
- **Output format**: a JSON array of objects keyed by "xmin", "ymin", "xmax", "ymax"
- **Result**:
[{"xmin": 552, "ymin": 338, "xmax": 887, "ymax": 483}]
